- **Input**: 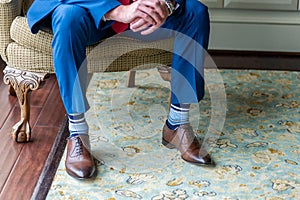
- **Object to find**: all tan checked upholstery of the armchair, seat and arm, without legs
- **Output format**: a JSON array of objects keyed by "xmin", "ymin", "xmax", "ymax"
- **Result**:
[{"xmin": 0, "ymin": 0, "xmax": 173, "ymax": 73}]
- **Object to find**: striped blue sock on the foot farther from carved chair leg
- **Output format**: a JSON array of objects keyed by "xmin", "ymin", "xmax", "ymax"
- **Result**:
[{"xmin": 166, "ymin": 104, "xmax": 190, "ymax": 130}]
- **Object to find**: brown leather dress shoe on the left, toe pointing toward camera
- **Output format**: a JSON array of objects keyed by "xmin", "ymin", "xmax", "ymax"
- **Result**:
[{"xmin": 65, "ymin": 135, "xmax": 96, "ymax": 179}]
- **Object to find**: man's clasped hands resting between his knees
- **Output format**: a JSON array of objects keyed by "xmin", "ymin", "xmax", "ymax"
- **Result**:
[{"xmin": 105, "ymin": 0, "xmax": 169, "ymax": 35}]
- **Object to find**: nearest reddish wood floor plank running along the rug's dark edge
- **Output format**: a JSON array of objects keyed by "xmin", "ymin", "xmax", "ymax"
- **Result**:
[{"xmin": 0, "ymin": 127, "xmax": 59, "ymax": 200}]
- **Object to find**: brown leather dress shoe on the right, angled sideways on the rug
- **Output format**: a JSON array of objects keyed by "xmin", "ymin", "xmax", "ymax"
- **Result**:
[{"xmin": 162, "ymin": 124, "xmax": 214, "ymax": 166}]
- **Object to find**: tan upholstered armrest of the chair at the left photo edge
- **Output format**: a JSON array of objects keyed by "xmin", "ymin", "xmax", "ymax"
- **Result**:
[{"xmin": 0, "ymin": 0, "xmax": 23, "ymax": 62}]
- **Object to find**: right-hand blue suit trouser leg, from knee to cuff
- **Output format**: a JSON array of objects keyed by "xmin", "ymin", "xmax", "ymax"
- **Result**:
[{"xmin": 162, "ymin": 0, "xmax": 210, "ymax": 104}]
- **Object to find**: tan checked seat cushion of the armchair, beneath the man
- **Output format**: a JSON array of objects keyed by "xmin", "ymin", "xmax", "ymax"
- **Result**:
[{"xmin": 8, "ymin": 16, "xmax": 173, "ymax": 72}]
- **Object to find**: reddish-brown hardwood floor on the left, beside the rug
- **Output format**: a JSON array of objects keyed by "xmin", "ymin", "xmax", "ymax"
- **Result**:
[{"xmin": 0, "ymin": 60, "xmax": 67, "ymax": 200}]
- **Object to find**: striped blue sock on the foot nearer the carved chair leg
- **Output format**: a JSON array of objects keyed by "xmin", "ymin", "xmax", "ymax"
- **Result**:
[{"xmin": 68, "ymin": 113, "xmax": 89, "ymax": 137}]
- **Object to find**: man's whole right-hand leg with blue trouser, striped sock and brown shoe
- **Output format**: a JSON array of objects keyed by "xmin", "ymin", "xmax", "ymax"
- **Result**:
[{"xmin": 163, "ymin": 0, "xmax": 213, "ymax": 165}]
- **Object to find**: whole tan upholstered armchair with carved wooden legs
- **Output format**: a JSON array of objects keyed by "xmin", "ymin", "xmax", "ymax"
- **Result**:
[{"xmin": 0, "ymin": 0, "xmax": 173, "ymax": 142}]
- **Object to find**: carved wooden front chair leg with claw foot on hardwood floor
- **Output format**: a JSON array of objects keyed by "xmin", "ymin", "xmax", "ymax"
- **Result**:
[{"xmin": 3, "ymin": 67, "xmax": 46, "ymax": 142}]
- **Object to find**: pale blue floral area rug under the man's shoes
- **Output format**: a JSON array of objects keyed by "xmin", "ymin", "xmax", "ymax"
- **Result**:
[{"xmin": 47, "ymin": 69, "xmax": 300, "ymax": 200}]
